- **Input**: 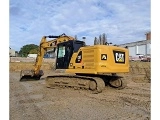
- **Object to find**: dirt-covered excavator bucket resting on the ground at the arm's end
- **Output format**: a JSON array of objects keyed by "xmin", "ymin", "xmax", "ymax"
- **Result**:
[{"xmin": 20, "ymin": 70, "xmax": 44, "ymax": 81}]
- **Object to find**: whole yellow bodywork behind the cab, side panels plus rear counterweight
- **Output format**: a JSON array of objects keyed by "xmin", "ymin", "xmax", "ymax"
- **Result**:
[{"xmin": 67, "ymin": 45, "xmax": 129, "ymax": 74}]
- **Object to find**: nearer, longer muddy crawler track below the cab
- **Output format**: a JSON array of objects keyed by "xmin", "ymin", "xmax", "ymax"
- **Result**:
[{"xmin": 45, "ymin": 75, "xmax": 105, "ymax": 93}]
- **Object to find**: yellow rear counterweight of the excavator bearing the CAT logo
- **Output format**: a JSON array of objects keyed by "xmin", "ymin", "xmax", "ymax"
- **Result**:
[{"xmin": 97, "ymin": 46, "xmax": 129, "ymax": 74}]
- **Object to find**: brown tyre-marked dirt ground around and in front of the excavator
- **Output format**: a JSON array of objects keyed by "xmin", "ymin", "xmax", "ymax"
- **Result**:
[{"xmin": 10, "ymin": 70, "xmax": 151, "ymax": 120}]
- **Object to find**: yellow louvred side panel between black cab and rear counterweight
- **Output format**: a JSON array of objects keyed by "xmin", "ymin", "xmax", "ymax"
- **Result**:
[{"xmin": 66, "ymin": 46, "xmax": 98, "ymax": 74}]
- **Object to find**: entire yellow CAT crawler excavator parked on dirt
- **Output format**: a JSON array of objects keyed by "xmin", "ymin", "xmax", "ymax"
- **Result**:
[{"xmin": 20, "ymin": 34, "xmax": 129, "ymax": 93}]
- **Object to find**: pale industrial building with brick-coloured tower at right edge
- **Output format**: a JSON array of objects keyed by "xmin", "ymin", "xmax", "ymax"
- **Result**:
[{"xmin": 119, "ymin": 32, "xmax": 151, "ymax": 56}]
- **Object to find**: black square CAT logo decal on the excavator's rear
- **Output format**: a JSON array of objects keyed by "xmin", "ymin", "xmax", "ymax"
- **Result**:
[{"xmin": 113, "ymin": 51, "xmax": 125, "ymax": 63}]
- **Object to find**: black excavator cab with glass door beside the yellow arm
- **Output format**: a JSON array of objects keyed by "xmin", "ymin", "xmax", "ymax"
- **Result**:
[{"xmin": 56, "ymin": 40, "xmax": 85, "ymax": 69}]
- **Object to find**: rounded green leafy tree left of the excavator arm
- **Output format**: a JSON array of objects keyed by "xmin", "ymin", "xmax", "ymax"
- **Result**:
[{"xmin": 19, "ymin": 44, "xmax": 39, "ymax": 57}]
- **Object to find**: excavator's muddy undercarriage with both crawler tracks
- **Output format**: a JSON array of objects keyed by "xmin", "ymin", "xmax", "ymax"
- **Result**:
[{"xmin": 45, "ymin": 75, "xmax": 126, "ymax": 93}]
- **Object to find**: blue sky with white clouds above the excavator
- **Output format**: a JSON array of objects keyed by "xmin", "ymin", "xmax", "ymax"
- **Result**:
[{"xmin": 9, "ymin": 0, "xmax": 151, "ymax": 51}]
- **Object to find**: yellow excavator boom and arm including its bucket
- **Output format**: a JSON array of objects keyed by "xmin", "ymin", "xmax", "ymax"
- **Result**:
[{"xmin": 20, "ymin": 34, "xmax": 75, "ymax": 81}]
